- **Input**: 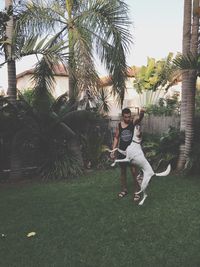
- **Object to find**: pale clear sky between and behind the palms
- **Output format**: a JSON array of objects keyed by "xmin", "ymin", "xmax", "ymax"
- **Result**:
[{"xmin": 0, "ymin": 0, "xmax": 184, "ymax": 89}]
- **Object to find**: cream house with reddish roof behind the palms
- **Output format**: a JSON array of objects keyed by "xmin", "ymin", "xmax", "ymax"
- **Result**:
[{"xmin": 17, "ymin": 65, "xmax": 181, "ymax": 119}]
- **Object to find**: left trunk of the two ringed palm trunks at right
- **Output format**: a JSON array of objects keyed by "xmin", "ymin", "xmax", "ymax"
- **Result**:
[{"xmin": 177, "ymin": 0, "xmax": 192, "ymax": 171}]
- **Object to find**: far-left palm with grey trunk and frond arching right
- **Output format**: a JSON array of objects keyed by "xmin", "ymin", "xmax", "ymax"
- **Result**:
[{"xmin": 0, "ymin": 0, "xmax": 67, "ymax": 103}]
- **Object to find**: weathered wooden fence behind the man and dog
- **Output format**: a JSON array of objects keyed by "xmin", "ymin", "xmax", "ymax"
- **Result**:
[{"xmin": 110, "ymin": 115, "xmax": 180, "ymax": 137}]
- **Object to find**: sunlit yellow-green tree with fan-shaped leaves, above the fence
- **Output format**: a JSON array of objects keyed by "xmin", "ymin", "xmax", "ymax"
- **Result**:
[{"xmin": 133, "ymin": 53, "xmax": 179, "ymax": 106}]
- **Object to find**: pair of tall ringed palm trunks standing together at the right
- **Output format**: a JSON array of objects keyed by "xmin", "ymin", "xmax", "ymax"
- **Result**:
[{"xmin": 175, "ymin": 0, "xmax": 199, "ymax": 170}]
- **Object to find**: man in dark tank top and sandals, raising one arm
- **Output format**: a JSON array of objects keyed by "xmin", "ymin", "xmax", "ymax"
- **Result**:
[{"xmin": 110, "ymin": 108, "xmax": 145, "ymax": 201}]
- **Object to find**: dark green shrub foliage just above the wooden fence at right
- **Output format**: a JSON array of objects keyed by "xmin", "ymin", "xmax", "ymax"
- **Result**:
[{"xmin": 146, "ymin": 94, "xmax": 180, "ymax": 116}]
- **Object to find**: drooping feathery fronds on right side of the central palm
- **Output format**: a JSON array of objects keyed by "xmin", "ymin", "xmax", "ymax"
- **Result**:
[{"xmin": 79, "ymin": 1, "xmax": 131, "ymax": 107}]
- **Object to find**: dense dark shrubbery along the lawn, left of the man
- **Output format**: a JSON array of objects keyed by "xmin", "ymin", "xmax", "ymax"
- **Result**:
[{"xmin": 0, "ymin": 88, "xmax": 110, "ymax": 180}]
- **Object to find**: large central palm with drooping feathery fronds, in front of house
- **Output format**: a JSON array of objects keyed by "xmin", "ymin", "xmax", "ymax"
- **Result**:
[{"xmin": 20, "ymin": 0, "xmax": 131, "ymax": 107}]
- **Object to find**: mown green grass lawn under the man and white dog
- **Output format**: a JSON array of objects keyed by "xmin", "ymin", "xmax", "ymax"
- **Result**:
[{"xmin": 0, "ymin": 169, "xmax": 200, "ymax": 267}]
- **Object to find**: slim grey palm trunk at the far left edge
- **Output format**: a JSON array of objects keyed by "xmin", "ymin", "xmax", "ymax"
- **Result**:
[{"xmin": 5, "ymin": 0, "xmax": 17, "ymax": 103}]
